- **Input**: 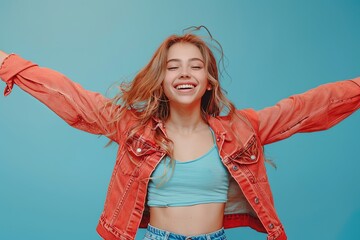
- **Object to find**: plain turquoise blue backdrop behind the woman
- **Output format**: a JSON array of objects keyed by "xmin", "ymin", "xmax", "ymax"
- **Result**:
[{"xmin": 0, "ymin": 0, "xmax": 360, "ymax": 240}]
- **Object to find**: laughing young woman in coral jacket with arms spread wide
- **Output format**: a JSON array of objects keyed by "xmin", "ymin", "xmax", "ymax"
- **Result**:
[{"xmin": 0, "ymin": 34, "xmax": 360, "ymax": 240}]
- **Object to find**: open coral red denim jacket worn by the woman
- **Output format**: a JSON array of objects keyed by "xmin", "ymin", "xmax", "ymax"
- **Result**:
[{"xmin": 0, "ymin": 54, "xmax": 360, "ymax": 240}]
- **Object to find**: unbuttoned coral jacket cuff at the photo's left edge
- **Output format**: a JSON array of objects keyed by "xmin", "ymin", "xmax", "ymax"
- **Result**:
[{"xmin": 0, "ymin": 54, "xmax": 36, "ymax": 96}]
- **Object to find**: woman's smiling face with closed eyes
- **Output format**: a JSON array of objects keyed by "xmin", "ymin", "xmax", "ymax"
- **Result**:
[{"xmin": 163, "ymin": 43, "xmax": 210, "ymax": 108}]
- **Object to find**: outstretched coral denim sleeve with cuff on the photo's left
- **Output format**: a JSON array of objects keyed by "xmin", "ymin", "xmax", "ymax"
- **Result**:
[{"xmin": 0, "ymin": 54, "xmax": 124, "ymax": 142}]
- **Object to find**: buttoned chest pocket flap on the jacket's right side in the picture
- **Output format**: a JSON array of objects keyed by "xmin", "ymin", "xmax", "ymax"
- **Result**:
[{"xmin": 230, "ymin": 136, "xmax": 261, "ymax": 165}]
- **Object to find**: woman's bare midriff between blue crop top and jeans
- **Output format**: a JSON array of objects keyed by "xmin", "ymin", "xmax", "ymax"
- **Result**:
[{"xmin": 150, "ymin": 203, "xmax": 225, "ymax": 236}]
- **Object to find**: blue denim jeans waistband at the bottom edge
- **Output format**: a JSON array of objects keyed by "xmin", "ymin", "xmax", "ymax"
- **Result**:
[{"xmin": 143, "ymin": 224, "xmax": 226, "ymax": 240}]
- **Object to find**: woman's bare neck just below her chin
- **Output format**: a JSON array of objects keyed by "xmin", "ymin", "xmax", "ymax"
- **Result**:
[{"xmin": 165, "ymin": 103, "xmax": 208, "ymax": 134}]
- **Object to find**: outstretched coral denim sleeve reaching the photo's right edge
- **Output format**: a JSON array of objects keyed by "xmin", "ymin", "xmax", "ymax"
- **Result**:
[{"xmin": 247, "ymin": 78, "xmax": 360, "ymax": 145}]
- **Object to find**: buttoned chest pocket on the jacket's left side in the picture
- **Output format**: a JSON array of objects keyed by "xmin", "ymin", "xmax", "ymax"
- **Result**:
[{"xmin": 120, "ymin": 136, "xmax": 156, "ymax": 176}]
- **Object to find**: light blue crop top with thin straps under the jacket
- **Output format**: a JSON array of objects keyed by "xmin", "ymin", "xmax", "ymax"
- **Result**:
[{"xmin": 147, "ymin": 130, "xmax": 229, "ymax": 207}]
